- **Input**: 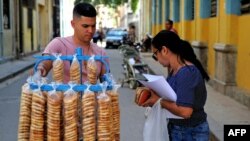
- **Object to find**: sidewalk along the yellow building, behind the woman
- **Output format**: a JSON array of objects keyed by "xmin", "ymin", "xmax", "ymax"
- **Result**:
[{"xmin": 142, "ymin": 53, "xmax": 250, "ymax": 141}]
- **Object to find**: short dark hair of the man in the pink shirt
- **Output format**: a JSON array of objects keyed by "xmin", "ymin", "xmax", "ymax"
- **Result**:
[{"xmin": 73, "ymin": 2, "xmax": 97, "ymax": 17}]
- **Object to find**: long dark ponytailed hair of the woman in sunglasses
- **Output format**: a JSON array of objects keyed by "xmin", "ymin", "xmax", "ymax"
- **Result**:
[{"xmin": 152, "ymin": 30, "xmax": 209, "ymax": 81}]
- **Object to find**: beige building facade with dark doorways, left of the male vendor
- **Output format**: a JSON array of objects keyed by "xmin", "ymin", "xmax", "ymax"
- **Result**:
[{"xmin": 0, "ymin": 0, "xmax": 60, "ymax": 60}]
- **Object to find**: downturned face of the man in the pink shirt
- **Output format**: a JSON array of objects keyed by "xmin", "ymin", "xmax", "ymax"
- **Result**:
[{"xmin": 71, "ymin": 16, "xmax": 96, "ymax": 42}]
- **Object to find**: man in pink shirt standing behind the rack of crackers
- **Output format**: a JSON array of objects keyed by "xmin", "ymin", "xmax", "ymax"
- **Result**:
[{"xmin": 38, "ymin": 3, "xmax": 106, "ymax": 83}]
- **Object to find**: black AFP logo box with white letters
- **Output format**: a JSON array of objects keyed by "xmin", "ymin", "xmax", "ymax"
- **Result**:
[{"xmin": 224, "ymin": 125, "xmax": 250, "ymax": 141}]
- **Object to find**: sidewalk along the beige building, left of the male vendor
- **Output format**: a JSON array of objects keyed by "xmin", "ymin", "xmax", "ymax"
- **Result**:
[{"xmin": 0, "ymin": 53, "xmax": 41, "ymax": 83}]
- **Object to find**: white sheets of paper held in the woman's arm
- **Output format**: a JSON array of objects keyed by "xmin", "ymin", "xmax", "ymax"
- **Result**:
[{"xmin": 139, "ymin": 74, "xmax": 183, "ymax": 119}]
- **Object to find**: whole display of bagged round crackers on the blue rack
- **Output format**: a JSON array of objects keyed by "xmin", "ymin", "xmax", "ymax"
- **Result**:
[{"xmin": 18, "ymin": 54, "xmax": 120, "ymax": 141}]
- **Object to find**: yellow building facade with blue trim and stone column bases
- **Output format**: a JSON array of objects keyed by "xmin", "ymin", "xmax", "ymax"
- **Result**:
[{"xmin": 140, "ymin": 0, "xmax": 250, "ymax": 107}]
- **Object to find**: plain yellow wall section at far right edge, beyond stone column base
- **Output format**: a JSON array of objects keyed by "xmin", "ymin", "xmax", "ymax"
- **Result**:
[{"xmin": 236, "ymin": 14, "xmax": 250, "ymax": 91}]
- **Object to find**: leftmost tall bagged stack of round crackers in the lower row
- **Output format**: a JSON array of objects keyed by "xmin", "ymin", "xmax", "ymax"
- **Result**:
[{"xmin": 18, "ymin": 83, "xmax": 32, "ymax": 141}]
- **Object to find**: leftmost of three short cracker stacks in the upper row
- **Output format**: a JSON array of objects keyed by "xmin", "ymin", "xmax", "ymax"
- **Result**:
[{"xmin": 52, "ymin": 60, "xmax": 64, "ymax": 83}]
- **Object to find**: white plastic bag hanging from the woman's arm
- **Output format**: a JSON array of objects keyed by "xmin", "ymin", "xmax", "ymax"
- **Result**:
[{"xmin": 143, "ymin": 99, "xmax": 168, "ymax": 141}]
